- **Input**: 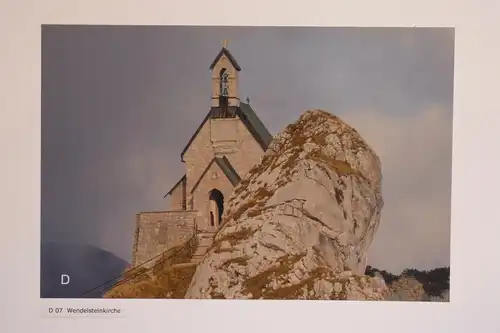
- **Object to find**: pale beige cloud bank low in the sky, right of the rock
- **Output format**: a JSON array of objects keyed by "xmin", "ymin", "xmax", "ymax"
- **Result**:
[{"xmin": 343, "ymin": 106, "xmax": 452, "ymax": 272}]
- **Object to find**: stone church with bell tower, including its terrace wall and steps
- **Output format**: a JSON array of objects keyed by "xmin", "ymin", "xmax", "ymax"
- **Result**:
[{"xmin": 132, "ymin": 41, "xmax": 272, "ymax": 266}]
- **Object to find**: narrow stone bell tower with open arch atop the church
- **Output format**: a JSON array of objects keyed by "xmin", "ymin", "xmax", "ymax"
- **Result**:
[{"xmin": 210, "ymin": 39, "xmax": 241, "ymax": 114}]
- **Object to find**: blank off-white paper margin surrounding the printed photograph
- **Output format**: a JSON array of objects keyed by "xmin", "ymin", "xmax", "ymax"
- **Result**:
[{"xmin": 0, "ymin": 0, "xmax": 500, "ymax": 333}]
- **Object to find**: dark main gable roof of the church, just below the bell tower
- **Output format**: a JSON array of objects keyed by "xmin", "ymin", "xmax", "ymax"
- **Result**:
[{"xmin": 181, "ymin": 103, "xmax": 273, "ymax": 161}]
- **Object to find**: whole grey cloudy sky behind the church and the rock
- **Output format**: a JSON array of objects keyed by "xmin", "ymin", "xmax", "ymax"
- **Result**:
[{"xmin": 41, "ymin": 26, "xmax": 454, "ymax": 273}]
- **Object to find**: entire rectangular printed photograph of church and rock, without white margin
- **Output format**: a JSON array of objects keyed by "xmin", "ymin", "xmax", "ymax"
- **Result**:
[{"xmin": 37, "ymin": 25, "xmax": 455, "ymax": 302}]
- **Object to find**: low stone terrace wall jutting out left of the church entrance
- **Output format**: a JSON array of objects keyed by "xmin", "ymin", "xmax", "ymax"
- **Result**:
[{"xmin": 132, "ymin": 211, "xmax": 197, "ymax": 267}]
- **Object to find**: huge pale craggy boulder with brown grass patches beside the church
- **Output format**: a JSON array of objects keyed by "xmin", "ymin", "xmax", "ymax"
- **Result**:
[{"xmin": 186, "ymin": 110, "xmax": 388, "ymax": 300}]
